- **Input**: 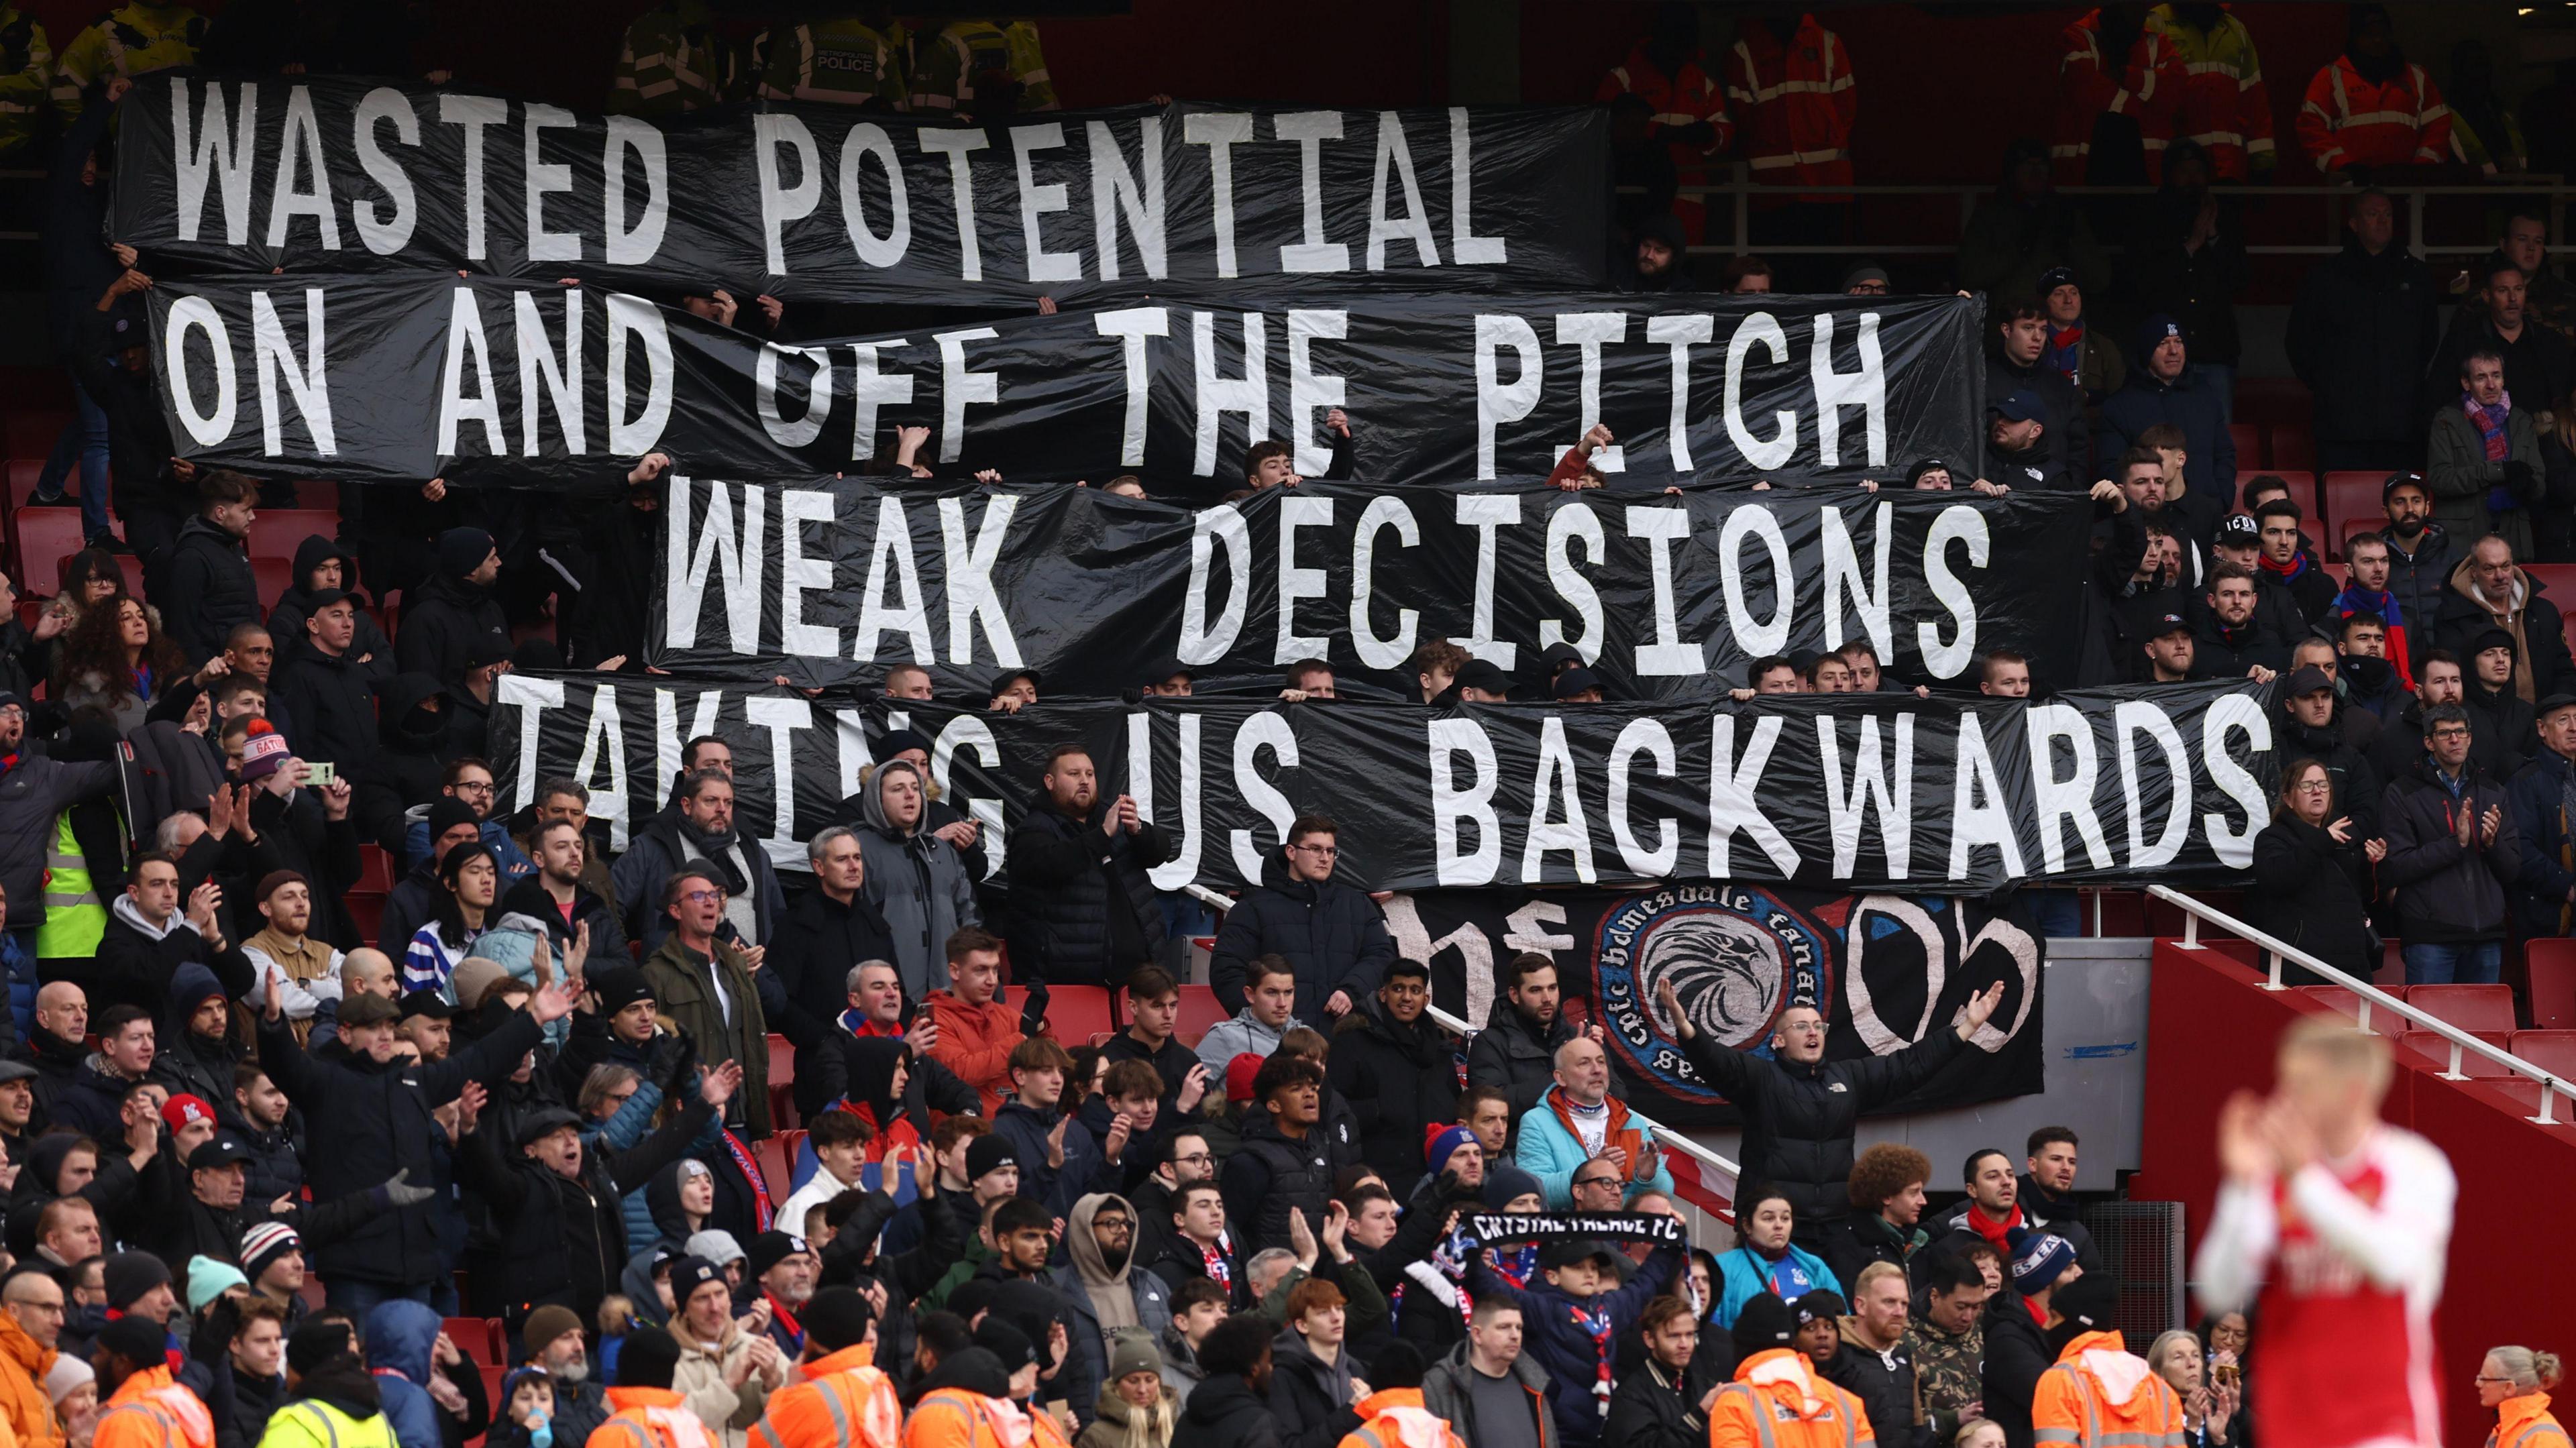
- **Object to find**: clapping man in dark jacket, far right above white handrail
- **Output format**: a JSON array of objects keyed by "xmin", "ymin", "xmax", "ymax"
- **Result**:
[{"xmin": 2377, "ymin": 704, "xmax": 2522, "ymax": 985}]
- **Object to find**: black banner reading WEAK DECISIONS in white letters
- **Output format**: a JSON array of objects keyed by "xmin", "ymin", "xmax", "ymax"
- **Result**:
[{"xmin": 649, "ymin": 477, "xmax": 2092, "ymax": 704}]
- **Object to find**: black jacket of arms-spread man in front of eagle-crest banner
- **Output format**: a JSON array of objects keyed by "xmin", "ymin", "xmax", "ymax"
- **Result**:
[{"xmin": 1682, "ymin": 1023, "xmax": 1963, "ymax": 1226}]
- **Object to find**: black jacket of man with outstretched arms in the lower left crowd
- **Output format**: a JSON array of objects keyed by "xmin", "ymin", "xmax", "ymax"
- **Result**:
[{"xmin": 260, "ymin": 1010, "xmax": 543, "ymax": 1288}]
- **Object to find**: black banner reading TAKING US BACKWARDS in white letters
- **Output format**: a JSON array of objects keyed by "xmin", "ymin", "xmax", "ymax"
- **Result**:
[{"xmin": 492, "ymin": 675, "xmax": 2275, "ymax": 894}]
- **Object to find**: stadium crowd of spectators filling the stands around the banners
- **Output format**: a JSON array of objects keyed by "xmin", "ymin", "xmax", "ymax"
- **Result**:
[{"xmin": 0, "ymin": 0, "xmax": 2544, "ymax": 1448}]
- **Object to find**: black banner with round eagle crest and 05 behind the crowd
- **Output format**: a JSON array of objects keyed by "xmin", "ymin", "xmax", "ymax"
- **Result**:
[{"xmin": 1386, "ymin": 881, "xmax": 2045, "ymax": 1128}]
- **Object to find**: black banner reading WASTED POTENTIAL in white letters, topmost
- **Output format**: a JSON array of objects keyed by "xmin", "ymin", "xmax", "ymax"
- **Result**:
[{"xmin": 113, "ymin": 70, "xmax": 1607, "ymax": 307}]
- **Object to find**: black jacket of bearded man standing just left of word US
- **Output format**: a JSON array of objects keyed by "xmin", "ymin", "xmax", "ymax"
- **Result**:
[{"xmin": 1007, "ymin": 789, "xmax": 1179, "ymax": 995}]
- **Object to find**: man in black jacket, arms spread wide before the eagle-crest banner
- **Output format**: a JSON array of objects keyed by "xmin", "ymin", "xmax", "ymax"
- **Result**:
[{"xmin": 1656, "ymin": 979, "xmax": 2004, "ymax": 1252}]
